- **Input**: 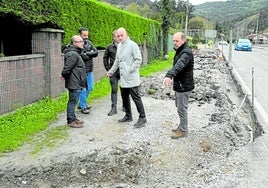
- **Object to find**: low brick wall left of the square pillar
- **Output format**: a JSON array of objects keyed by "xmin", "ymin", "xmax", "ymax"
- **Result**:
[{"xmin": 0, "ymin": 54, "xmax": 45, "ymax": 114}]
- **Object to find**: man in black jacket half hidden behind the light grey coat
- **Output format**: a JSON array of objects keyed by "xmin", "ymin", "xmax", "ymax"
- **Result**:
[{"xmin": 103, "ymin": 30, "xmax": 124, "ymax": 116}]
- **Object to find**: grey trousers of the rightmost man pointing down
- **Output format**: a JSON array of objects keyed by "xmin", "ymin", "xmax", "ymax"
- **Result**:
[{"xmin": 175, "ymin": 91, "xmax": 191, "ymax": 132}]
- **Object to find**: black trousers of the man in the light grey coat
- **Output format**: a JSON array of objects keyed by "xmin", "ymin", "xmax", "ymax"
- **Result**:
[{"xmin": 121, "ymin": 86, "xmax": 145, "ymax": 118}]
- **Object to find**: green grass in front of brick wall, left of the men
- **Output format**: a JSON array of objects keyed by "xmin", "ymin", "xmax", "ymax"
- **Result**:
[{"xmin": 0, "ymin": 94, "xmax": 67, "ymax": 153}]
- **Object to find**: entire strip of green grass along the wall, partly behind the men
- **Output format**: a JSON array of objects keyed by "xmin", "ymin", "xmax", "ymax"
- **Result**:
[{"xmin": 0, "ymin": 54, "xmax": 172, "ymax": 155}]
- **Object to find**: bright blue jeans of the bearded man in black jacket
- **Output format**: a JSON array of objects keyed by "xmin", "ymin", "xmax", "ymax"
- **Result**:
[{"xmin": 79, "ymin": 72, "xmax": 94, "ymax": 109}]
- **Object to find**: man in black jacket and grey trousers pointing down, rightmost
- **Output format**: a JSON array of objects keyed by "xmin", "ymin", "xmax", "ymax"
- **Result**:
[{"xmin": 164, "ymin": 32, "xmax": 194, "ymax": 139}]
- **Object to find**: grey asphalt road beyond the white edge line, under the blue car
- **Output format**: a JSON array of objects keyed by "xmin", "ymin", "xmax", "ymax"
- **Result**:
[{"xmin": 220, "ymin": 43, "xmax": 268, "ymax": 127}]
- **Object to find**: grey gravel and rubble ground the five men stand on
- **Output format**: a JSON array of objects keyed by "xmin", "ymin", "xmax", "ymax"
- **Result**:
[{"xmin": 0, "ymin": 48, "xmax": 260, "ymax": 188}]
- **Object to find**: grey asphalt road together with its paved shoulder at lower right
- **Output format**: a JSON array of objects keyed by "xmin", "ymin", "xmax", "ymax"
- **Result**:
[{"xmin": 220, "ymin": 45, "xmax": 268, "ymax": 188}]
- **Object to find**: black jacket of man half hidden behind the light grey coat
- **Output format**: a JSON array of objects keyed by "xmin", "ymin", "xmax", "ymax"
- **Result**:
[{"xmin": 103, "ymin": 42, "xmax": 120, "ymax": 77}]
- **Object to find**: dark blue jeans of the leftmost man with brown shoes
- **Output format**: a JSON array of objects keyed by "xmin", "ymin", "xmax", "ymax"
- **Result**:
[{"xmin": 67, "ymin": 89, "xmax": 81, "ymax": 124}]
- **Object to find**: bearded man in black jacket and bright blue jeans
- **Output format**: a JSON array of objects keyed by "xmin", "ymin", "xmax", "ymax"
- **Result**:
[{"xmin": 78, "ymin": 27, "xmax": 98, "ymax": 114}]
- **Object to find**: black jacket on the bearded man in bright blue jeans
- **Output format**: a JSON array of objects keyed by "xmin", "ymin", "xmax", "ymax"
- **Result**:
[{"xmin": 81, "ymin": 39, "xmax": 99, "ymax": 73}]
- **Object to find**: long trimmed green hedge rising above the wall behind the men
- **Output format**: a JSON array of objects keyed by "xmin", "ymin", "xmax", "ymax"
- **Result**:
[{"xmin": 0, "ymin": 0, "xmax": 161, "ymax": 52}]
